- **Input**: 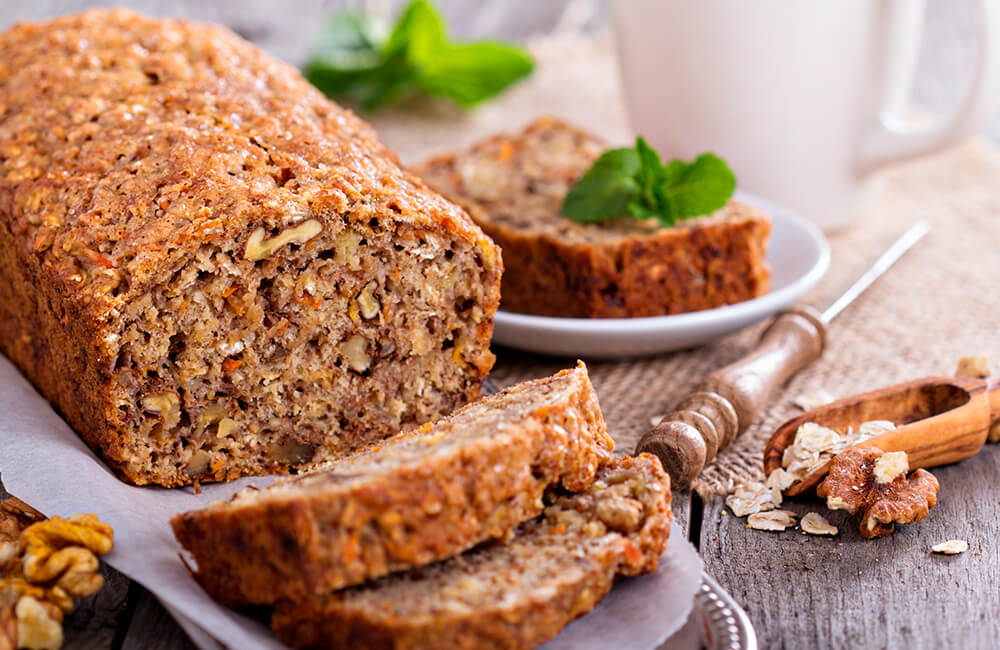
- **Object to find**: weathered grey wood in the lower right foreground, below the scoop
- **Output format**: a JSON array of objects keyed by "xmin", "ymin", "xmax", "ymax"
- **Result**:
[{"xmin": 700, "ymin": 445, "xmax": 1000, "ymax": 649}]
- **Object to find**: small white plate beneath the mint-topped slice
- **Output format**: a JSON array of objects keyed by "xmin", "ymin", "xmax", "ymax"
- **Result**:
[{"xmin": 493, "ymin": 192, "xmax": 830, "ymax": 360}]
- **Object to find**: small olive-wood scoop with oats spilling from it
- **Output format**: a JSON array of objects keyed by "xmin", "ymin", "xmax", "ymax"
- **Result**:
[{"xmin": 764, "ymin": 377, "xmax": 1000, "ymax": 496}]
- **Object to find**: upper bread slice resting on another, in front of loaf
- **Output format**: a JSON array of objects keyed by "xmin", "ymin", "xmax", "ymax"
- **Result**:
[{"xmin": 171, "ymin": 363, "xmax": 614, "ymax": 605}]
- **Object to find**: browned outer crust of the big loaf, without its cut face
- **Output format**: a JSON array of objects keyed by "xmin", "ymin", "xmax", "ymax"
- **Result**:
[{"xmin": 0, "ymin": 9, "xmax": 502, "ymax": 485}]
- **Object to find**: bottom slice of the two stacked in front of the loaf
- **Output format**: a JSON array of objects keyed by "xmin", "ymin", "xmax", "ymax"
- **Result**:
[{"xmin": 271, "ymin": 454, "xmax": 671, "ymax": 650}]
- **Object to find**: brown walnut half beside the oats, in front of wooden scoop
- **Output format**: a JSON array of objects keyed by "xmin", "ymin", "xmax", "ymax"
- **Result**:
[{"xmin": 816, "ymin": 447, "xmax": 940, "ymax": 539}]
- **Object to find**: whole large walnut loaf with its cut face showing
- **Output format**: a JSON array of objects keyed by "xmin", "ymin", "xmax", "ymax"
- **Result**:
[{"xmin": 0, "ymin": 10, "xmax": 501, "ymax": 486}]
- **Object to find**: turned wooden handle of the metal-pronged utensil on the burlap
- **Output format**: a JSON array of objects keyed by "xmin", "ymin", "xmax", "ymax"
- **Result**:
[{"xmin": 635, "ymin": 307, "xmax": 826, "ymax": 489}]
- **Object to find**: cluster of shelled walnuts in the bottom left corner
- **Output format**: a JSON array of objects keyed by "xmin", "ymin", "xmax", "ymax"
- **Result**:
[{"xmin": 0, "ymin": 499, "xmax": 114, "ymax": 650}]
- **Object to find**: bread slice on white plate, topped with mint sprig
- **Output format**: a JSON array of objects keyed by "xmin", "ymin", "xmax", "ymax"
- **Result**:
[{"xmin": 416, "ymin": 117, "xmax": 771, "ymax": 317}]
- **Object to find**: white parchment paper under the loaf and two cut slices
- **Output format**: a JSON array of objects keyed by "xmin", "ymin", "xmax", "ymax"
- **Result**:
[{"xmin": 0, "ymin": 356, "xmax": 701, "ymax": 650}]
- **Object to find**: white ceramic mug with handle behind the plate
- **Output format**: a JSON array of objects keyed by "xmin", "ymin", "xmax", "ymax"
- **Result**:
[{"xmin": 614, "ymin": 0, "xmax": 1000, "ymax": 231}]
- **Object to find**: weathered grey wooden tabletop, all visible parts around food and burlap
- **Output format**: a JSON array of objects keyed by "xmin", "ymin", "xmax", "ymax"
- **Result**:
[{"xmin": 0, "ymin": 0, "xmax": 1000, "ymax": 650}]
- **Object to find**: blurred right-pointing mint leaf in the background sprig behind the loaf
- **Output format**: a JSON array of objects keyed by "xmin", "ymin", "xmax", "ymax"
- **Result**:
[{"xmin": 417, "ymin": 43, "xmax": 534, "ymax": 107}]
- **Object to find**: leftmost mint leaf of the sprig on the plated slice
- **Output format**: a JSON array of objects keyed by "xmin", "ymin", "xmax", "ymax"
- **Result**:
[{"xmin": 562, "ymin": 149, "xmax": 640, "ymax": 222}]
